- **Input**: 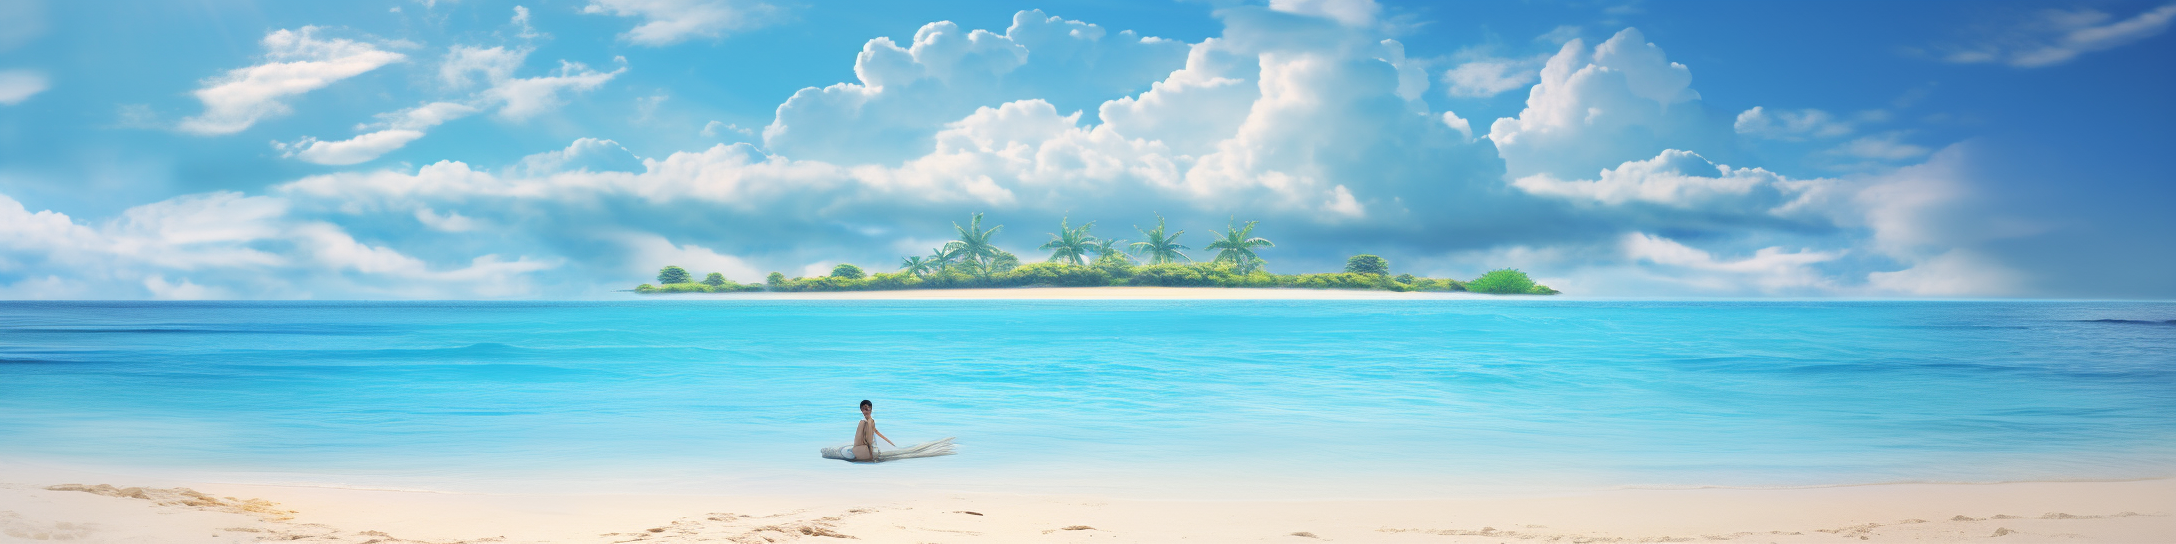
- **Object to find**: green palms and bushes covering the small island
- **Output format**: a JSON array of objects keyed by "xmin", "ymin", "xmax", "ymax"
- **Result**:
[{"xmin": 633, "ymin": 213, "xmax": 1558, "ymax": 294}]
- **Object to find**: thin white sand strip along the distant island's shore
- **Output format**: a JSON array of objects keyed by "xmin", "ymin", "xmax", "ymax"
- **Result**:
[{"xmin": 644, "ymin": 287, "xmax": 1497, "ymax": 300}]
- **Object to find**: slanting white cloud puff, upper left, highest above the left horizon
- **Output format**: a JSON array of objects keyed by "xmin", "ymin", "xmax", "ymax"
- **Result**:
[{"xmin": 178, "ymin": 26, "xmax": 407, "ymax": 135}]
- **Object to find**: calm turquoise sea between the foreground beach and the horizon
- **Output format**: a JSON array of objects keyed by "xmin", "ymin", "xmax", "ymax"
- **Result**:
[{"xmin": 0, "ymin": 298, "xmax": 2176, "ymax": 498}]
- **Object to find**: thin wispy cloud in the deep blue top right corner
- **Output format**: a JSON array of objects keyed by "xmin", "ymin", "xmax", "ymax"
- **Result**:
[{"xmin": 1941, "ymin": 4, "xmax": 2176, "ymax": 67}]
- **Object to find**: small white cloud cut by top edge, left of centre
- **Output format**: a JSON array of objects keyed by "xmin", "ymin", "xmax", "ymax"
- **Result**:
[{"xmin": 581, "ymin": 0, "xmax": 783, "ymax": 46}]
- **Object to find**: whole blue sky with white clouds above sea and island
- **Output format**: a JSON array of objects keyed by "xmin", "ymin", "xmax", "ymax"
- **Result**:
[{"xmin": 0, "ymin": 0, "xmax": 2176, "ymax": 300}]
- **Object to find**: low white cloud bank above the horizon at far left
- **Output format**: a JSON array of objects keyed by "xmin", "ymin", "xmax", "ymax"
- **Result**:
[{"xmin": 0, "ymin": 191, "xmax": 559, "ymax": 298}]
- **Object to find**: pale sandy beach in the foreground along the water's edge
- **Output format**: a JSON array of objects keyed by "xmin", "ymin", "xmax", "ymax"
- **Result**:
[{"xmin": 0, "ymin": 479, "xmax": 2176, "ymax": 544}]
